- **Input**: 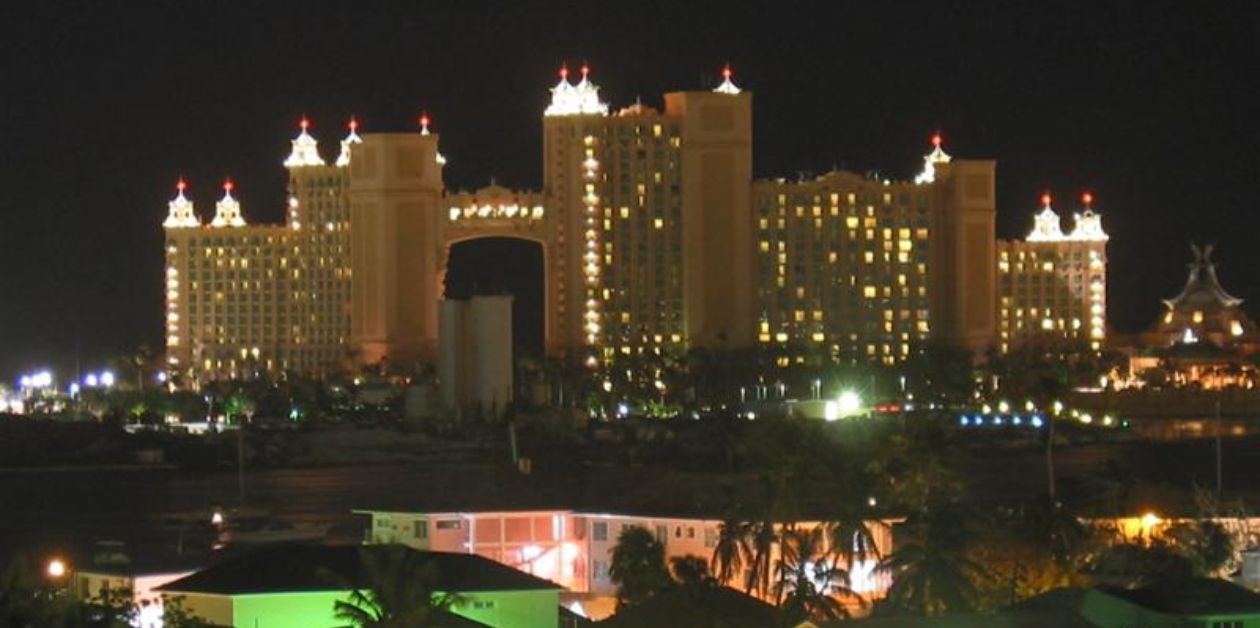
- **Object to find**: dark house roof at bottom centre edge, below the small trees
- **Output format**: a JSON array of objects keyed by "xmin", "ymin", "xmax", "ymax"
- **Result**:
[{"xmin": 595, "ymin": 586, "xmax": 777, "ymax": 628}]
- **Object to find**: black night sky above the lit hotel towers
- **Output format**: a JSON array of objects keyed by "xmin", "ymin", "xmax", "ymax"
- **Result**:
[{"xmin": 0, "ymin": 0, "xmax": 1260, "ymax": 376}]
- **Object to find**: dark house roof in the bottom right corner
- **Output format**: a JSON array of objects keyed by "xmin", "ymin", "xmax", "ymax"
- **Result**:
[{"xmin": 1108, "ymin": 578, "xmax": 1260, "ymax": 615}]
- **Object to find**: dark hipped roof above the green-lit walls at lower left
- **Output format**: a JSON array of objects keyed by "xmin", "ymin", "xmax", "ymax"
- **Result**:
[{"xmin": 159, "ymin": 544, "xmax": 561, "ymax": 595}]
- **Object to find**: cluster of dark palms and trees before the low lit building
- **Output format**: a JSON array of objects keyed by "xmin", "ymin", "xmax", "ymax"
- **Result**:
[{"xmin": 594, "ymin": 403, "xmax": 1237, "ymax": 619}]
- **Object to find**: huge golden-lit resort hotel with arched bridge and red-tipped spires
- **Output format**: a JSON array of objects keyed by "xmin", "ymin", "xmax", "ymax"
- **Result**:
[{"xmin": 165, "ymin": 67, "xmax": 1106, "ymax": 380}]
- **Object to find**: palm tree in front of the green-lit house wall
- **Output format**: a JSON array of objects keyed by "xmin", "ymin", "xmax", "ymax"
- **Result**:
[{"xmin": 333, "ymin": 545, "xmax": 464, "ymax": 628}]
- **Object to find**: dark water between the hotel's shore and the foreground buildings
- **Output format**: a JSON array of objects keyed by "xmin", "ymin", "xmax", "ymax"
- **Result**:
[{"xmin": 0, "ymin": 439, "xmax": 1260, "ymax": 560}]
